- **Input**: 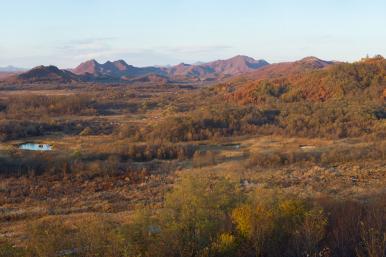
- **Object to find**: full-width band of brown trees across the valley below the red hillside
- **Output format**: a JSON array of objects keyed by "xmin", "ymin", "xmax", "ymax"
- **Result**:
[{"xmin": 0, "ymin": 100, "xmax": 386, "ymax": 143}]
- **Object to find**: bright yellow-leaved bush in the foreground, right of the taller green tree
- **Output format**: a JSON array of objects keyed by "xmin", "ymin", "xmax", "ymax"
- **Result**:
[{"xmin": 232, "ymin": 195, "xmax": 327, "ymax": 256}]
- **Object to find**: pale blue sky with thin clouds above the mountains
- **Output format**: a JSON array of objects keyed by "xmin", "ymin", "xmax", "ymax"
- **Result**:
[{"xmin": 0, "ymin": 0, "xmax": 386, "ymax": 68}]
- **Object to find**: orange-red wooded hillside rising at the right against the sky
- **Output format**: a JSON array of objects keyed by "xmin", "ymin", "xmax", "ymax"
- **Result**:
[{"xmin": 220, "ymin": 56, "xmax": 386, "ymax": 104}]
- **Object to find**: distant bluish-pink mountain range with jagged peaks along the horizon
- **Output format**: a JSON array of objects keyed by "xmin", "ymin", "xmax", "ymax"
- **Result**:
[{"xmin": 3, "ymin": 55, "xmax": 334, "ymax": 83}]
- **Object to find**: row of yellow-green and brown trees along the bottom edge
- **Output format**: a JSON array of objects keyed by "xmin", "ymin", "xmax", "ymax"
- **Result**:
[{"xmin": 0, "ymin": 173, "xmax": 386, "ymax": 257}]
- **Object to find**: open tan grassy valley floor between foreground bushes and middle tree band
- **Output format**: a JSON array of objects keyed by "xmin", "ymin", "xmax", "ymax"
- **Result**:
[{"xmin": 0, "ymin": 136, "xmax": 386, "ymax": 243}]
